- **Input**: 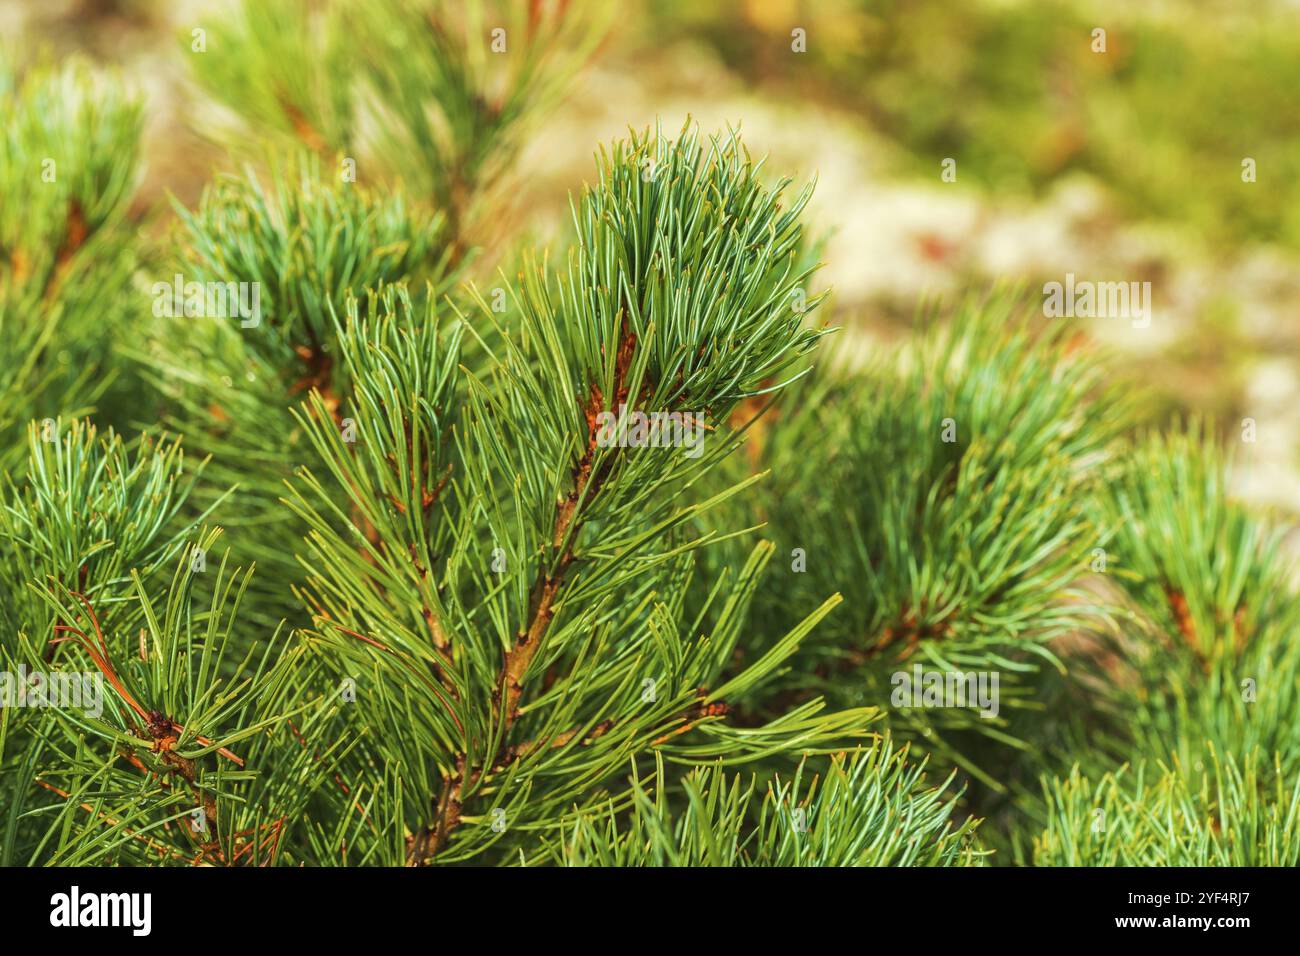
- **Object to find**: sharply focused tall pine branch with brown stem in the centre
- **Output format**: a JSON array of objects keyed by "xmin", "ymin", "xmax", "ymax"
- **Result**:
[{"xmin": 280, "ymin": 125, "xmax": 870, "ymax": 864}]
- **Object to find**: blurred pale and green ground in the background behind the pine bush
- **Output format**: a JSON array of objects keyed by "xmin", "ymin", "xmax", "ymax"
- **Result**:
[{"xmin": 0, "ymin": 0, "xmax": 1300, "ymax": 514}]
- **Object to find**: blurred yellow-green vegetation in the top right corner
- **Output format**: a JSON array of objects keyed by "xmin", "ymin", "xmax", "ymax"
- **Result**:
[{"xmin": 651, "ymin": 0, "xmax": 1300, "ymax": 247}]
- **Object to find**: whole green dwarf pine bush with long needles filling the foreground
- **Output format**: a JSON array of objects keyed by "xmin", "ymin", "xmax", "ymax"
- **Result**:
[{"xmin": 0, "ymin": 0, "xmax": 1300, "ymax": 866}]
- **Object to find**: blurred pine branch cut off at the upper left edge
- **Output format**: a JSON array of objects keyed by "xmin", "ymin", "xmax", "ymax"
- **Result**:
[{"xmin": 0, "ymin": 53, "xmax": 142, "ymax": 470}]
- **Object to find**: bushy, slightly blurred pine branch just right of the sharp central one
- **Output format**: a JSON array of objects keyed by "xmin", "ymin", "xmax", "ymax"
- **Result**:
[{"xmin": 712, "ymin": 294, "xmax": 1128, "ymax": 790}]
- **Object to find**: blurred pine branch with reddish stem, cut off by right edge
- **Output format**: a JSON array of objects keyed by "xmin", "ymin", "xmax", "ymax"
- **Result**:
[{"xmin": 1060, "ymin": 424, "xmax": 1300, "ymax": 774}]
